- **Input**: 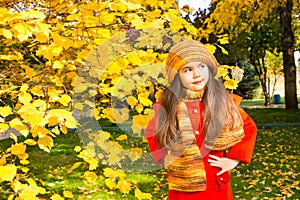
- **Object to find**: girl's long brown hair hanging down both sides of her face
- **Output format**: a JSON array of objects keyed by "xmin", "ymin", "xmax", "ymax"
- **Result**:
[{"xmin": 157, "ymin": 70, "xmax": 233, "ymax": 147}]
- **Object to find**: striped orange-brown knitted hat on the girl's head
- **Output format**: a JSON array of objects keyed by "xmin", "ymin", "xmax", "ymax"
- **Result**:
[{"xmin": 166, "ymin": 40, "xmax": 218, "ymax": 83}]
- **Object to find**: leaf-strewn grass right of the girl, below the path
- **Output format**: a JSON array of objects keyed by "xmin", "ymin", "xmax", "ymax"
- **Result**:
[{"xmin": 231, "ymin": 127, "xmax": 300, "ymax": 200}]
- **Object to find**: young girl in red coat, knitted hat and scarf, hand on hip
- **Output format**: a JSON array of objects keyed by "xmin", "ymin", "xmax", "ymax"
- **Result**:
[{"xmin": 145, "ymin": 40, "xmax": 256, "ymax": 200}]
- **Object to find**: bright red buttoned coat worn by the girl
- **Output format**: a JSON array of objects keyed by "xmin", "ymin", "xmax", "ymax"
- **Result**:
[{"xmin": 145, "ymin": 96, "xmax": 256, "ymax": 200}]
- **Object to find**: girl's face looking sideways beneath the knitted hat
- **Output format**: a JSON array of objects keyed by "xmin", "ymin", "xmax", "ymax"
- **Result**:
[{"xmin": 179, "ymin": 62, "xmax": 209, "ymax": 91}]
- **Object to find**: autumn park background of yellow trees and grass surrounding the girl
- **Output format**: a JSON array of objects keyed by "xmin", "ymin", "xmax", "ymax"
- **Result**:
[{"xmin": 0, "ymin": 0, "xmax": 300, "ymax": 200}]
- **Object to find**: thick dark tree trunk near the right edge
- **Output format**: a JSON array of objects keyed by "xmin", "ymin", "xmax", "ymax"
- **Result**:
[{"xmin": 279, "ymin": 0, "xmax": 298, "ymax": 109}]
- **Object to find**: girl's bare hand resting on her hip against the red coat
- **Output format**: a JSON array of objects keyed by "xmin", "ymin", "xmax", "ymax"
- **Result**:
[{"xmin": 208, "ymin": 155, "xmax": 239, "ymax": 176}]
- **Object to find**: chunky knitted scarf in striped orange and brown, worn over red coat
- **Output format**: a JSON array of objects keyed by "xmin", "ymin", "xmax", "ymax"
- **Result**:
[{"xmin": 165, "ymin": 90, "xmax": 244, "ymax": 192}]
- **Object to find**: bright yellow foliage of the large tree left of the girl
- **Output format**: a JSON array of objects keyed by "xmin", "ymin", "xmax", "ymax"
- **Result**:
[{"xmin": 0, "ymin": 0, "xmax": 237, "ymax": 200}]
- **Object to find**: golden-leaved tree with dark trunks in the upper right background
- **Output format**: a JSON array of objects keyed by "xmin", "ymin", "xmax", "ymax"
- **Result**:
[{"xmin": 200, "ymin": 0, "xmax": 299, "ymax": 109}]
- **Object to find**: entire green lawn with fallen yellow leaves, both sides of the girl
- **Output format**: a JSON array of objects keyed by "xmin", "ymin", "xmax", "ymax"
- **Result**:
[{"xmin": 0, "ymin": 108, "xmax": 300, "ymax": 200}]
